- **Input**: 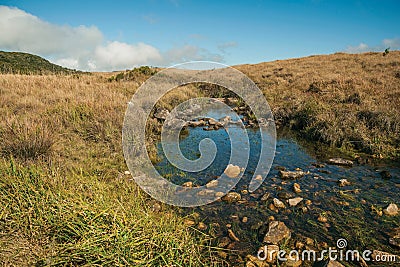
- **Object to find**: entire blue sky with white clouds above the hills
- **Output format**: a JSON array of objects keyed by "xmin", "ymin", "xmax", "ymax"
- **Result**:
[{"xmin": 0, "ymin": 0, "xmax": 400, "ymax": 71}]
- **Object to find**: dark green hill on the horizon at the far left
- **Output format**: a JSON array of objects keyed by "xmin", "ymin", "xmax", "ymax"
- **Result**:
[{"xmin": 0, "ymin": 51, "xmax": 78, "ymax": 74}]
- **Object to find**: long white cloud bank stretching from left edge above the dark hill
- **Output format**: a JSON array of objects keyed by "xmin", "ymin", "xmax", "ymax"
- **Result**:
[{"xmin": 0, "ymin": 6, "xmax": 219, "ymax": 71}]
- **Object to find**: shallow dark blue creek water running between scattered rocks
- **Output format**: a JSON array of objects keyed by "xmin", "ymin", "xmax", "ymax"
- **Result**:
[{"xmin": 156, "ymin": 107, "xmax": 400, "ymax": 266}]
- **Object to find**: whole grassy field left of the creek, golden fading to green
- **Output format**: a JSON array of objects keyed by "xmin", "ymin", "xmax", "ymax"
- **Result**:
[{"xmin": 0, "ymin": 73, "xmax": 222, "ymax": 266}]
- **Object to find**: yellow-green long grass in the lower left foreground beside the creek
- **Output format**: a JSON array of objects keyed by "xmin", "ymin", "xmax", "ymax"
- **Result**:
[{"xmin": 0, "ymin": 158, "xmax": 219, "ymax": 266}]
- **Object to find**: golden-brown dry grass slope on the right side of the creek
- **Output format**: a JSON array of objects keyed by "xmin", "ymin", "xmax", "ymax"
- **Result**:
[{"xmin": 236, "ymin": 51, "xmax": 400, "ymax": 158}]
